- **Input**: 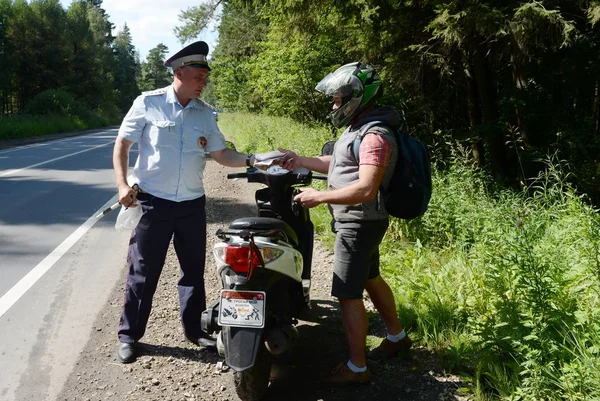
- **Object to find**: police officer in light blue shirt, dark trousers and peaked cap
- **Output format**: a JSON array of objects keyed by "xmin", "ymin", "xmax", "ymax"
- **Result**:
[{"xmin": 113, "ymin": 41, "xmax": 255, "ymax": 363}]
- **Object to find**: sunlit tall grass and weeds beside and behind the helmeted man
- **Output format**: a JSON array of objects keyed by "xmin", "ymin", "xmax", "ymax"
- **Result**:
[{"xmin": 220, "ymin": 113, "xmax": 600, "ymax": 401}]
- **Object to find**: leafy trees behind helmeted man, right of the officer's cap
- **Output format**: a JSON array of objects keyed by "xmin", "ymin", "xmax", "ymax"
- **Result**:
[{"xmin": 182, "ymin": 0, "xmax": 600, "ymax": 201}]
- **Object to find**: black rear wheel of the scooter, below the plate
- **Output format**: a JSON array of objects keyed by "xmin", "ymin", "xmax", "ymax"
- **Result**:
[{"xmin": 233, "ymin": 344, "xmax": 273, "ymax": 401}]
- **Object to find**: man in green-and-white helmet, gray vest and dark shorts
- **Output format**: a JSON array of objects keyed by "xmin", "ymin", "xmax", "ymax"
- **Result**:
[{"xmin": 280, "ymin": 62, "xmax": 412, "ymax": 385}]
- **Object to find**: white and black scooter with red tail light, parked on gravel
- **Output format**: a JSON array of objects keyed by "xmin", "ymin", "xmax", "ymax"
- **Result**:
[{"xmin": 202, "ymin": 166, "xmax": 327, "ymax": 401}]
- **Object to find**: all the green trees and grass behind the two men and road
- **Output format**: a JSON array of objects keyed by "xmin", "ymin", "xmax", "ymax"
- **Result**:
[{"xmin": 0, "ymin": 0, "xmax": 600, "ymax": 400}]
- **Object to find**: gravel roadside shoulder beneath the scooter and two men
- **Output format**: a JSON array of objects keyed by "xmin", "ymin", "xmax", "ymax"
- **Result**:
[{"xmin": 56, "ymin": 161, "xmax": 461, "ymax": 401}]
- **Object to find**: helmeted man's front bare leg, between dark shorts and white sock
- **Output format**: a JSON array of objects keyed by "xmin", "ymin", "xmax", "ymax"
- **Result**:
[{"xmin": 340, "ymin": 298, "xmax": 368, "ymax": 367}]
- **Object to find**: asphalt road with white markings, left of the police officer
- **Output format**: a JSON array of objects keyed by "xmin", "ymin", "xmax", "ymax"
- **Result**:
[{"xmin": 0, "ymin": 129, "xmax": 136, "ymax": 401}]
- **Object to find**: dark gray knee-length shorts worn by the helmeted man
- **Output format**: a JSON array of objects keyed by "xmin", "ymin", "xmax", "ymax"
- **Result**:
[{"xmin": 331, "ymin": 220, "xmax": 388, "ymax": 299}]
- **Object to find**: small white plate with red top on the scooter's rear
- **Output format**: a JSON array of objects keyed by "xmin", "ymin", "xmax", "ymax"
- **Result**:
[{"xmin": 219, "ymin": 290, "xmax": 265, "ymax": 328}]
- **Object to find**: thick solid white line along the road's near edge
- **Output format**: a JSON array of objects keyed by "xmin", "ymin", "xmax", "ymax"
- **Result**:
[{"xmin": 0, "ymin": 195, "xmax": 117, "ymax": 317}]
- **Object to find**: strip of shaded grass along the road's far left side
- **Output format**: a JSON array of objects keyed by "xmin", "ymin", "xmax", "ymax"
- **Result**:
[{"xmin": 0, "ymin": 115, "xmax": 120, "ymax": 140}]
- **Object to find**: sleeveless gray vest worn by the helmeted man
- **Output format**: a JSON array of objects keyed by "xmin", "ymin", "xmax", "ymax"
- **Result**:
[{"xmin": 327, "ymin": 124, "xmax": 398, "ymax": 223}]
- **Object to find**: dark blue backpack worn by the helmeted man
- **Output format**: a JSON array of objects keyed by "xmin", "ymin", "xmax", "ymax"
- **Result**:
[{"xmin": 352, "ymin": 121, "xmax": 432, "ymax": 220}]
